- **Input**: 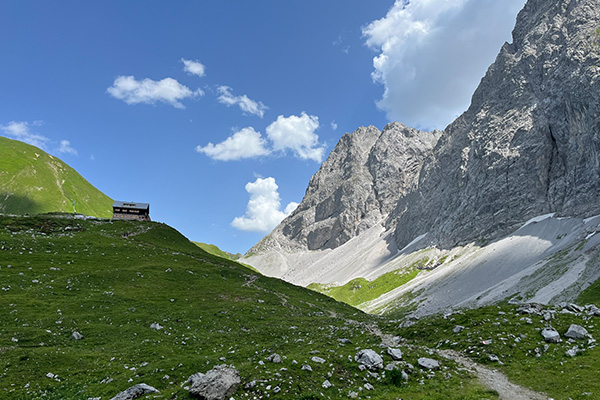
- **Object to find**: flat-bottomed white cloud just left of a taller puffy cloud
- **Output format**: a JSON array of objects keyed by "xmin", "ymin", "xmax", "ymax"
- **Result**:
[{"xmin": 196, "ymin": 127, "xmax": 270, "ymax": 161}]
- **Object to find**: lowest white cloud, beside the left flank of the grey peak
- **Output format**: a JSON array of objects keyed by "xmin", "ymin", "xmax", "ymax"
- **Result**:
[{"xmin": 231, "ymin": 178, "xmax": 298, "ymax": 233}]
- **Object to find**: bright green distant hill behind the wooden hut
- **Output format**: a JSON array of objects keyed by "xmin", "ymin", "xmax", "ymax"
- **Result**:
[{"xmin": 0, "ymin": 137, "xmax": 112, "ymax": 218}]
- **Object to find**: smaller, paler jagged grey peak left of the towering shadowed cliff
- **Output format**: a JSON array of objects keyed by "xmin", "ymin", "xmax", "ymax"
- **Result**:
[{"xmin": 250, "ymin": 123, "xmax": 440, "ymax": 253}]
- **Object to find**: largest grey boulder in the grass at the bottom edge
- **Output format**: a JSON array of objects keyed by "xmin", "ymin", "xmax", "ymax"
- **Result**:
[{"xmin": 189, "ymin": 365, "xmax": 241, "ymax": 400}]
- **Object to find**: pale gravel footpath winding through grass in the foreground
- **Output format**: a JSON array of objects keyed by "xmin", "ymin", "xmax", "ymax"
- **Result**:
[{"xmin": 438, "ymin": 350, "xmax": 552, "ymax": 400}]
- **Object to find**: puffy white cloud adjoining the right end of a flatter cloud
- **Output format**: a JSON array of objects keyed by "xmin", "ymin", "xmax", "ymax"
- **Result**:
[{"xmin": 266, "ymin": 112, "xmax": 325, "ymax": 162}]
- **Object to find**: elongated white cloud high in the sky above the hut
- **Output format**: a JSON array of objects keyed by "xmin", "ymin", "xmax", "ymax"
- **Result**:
[{"xmin": 106, "ymin": 76, "xmax": 204, "ymax": 108}]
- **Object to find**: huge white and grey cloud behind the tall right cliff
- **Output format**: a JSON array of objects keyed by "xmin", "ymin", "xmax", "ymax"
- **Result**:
[{"xmin": 363, "ymin": 0, "xmax": 525, "ymax": 129}]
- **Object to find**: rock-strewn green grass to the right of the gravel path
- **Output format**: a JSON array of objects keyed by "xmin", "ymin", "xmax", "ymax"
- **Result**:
[{"xmin": 390, "ymin": 304, "xmax": 600, "ymax": 400}]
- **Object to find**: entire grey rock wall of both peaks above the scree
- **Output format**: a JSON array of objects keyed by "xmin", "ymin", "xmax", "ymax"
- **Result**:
[{"xmin": 251, "ymin": 0, "xmax": 600, "ymax": 252}]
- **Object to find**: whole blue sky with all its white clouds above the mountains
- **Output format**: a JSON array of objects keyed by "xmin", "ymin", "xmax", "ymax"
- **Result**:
[{"xmin": 0, "ymin": 0, "xmax": 525, "ymax": 252}]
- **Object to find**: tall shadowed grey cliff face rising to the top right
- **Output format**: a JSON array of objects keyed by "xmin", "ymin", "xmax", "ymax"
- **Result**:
[{"xmin": 388, "ymin": 0, "xmax": 600, "ymax": 250}]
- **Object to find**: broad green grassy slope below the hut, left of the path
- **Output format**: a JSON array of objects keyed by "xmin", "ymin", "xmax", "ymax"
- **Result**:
[{"xmin": 0, "ymin": 216, "xmax": 497, "ymax": 400}]
